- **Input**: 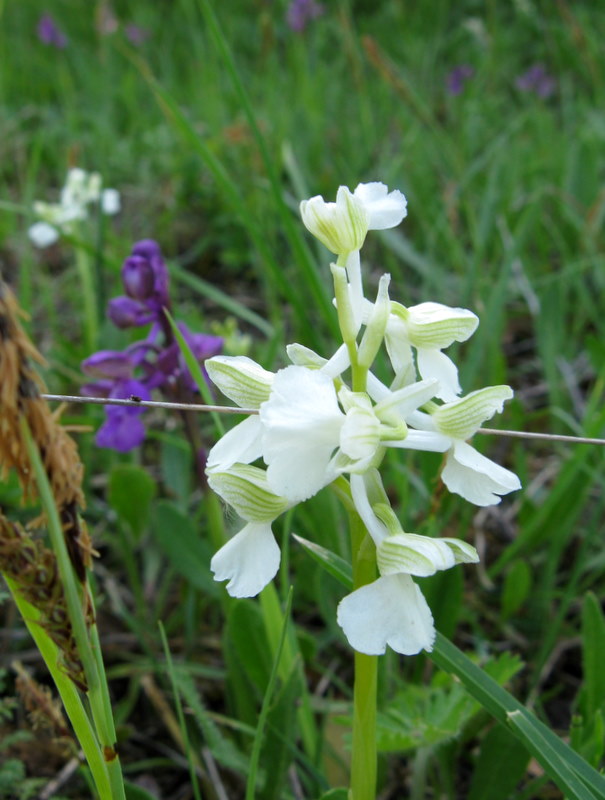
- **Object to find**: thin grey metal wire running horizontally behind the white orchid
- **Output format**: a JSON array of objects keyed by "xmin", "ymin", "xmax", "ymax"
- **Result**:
[{"xmin": 42, "ymin": 394, "xmax": 605, "ymax": 445}]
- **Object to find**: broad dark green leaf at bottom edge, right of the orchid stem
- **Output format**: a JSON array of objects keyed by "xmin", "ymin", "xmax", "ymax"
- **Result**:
[{"xmin": 468, "ymin": 724, "xmax": 529, "ymax": 800}]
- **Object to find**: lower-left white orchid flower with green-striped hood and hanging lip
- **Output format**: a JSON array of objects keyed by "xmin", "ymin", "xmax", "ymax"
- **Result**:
[{"xmin": 208, "ymin": 464, "xmax": 289, "ymax": 597}]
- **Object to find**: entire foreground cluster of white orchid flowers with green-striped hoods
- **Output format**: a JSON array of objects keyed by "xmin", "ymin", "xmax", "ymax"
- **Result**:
[{"xmin": 206, "ymin": 183, "xmax": 520, "ymax": 655}]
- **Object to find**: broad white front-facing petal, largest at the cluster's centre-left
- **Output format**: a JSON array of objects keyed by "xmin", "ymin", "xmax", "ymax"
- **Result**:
[{"xmin": 260, "ymin": 366, "xmax": 345, "ymax": 503}]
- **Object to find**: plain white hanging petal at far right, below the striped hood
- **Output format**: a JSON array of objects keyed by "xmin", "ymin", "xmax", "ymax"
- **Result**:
[{"xmin": 441, "ymin": 442, "xmax": 521, "ymax": 506}]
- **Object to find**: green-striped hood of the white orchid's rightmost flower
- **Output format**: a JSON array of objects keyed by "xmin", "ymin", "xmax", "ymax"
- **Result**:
[{"xmin": 432, "ymin": 386, "xmax": 513, "ymax": 439}]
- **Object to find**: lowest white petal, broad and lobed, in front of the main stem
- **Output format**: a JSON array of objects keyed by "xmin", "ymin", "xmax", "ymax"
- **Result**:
[{"xmin": 337, "ymin": 575, "xmax": 435, "ymax": 656}]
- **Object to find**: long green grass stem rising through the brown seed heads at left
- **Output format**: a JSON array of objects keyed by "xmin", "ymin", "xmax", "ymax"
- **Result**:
[{"xmin": 21, "ymin": 419, "xmax": 125, "ymax": 800}]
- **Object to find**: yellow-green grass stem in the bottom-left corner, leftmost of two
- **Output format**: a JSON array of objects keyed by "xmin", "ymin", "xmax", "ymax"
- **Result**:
[{"xmin": 4, "ymin": 575, "xmax": 111, "ymax": 800}]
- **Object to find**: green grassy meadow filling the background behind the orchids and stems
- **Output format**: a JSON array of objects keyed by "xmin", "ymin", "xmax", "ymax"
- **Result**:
[{"xmin": 0, "ymin": 0, "xmax": 605, "ymax": 800}]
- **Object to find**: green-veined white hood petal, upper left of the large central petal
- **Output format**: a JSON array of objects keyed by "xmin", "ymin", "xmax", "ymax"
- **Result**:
[{"xmin": 204, "ymin": 356, "xmax": 274, "ymax": 408}]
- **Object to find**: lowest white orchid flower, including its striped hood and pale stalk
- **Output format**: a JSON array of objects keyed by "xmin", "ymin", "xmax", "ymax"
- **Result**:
[{"xmin": 337, "ymin": 470, "xmax": 479, "ymax": 655}]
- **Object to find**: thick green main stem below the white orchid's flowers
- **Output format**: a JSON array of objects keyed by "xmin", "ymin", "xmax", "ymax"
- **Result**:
[{"xmin": 349, "ymin": 512, "xmax": 378, "ymax": 800}]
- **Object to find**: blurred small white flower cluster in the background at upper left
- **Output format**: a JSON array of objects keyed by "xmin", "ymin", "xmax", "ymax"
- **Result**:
[{"xmin": 28, "ymin": 167, "xmax": 120, "ymax": 247}]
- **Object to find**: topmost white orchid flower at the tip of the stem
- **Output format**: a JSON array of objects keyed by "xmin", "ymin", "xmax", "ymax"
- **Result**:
[{"xmin": 300, "ymin": 182, "xmax": 407, "ymax": 255}]
